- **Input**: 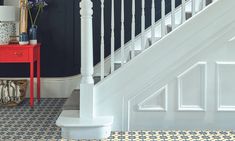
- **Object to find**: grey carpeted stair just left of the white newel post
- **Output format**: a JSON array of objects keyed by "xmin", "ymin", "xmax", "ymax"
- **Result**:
[{"xmin": 63, "ymin": 89, "xmax": 80, "ymax": 110}]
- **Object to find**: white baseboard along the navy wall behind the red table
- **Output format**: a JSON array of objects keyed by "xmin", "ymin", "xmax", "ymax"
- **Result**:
[{"xmin": 0, "ymin": 75, "xmax": 80, "ymax": 98}]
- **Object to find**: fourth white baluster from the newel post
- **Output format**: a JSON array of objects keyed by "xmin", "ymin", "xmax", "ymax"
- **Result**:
[{"xmin": 131, "ymin": 0, "xmax": 135, "ymax": 58}]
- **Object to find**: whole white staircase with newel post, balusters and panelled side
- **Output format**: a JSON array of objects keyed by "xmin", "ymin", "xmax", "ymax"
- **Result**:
[{"xmin": 57, "ymin": 0, "xmax": 235, "ymax": 139}]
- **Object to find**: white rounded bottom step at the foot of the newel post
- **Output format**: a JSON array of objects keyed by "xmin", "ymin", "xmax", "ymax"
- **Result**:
[{"xmin": 56, "ymin": 110, "xmax": 113, "ymax": 140}]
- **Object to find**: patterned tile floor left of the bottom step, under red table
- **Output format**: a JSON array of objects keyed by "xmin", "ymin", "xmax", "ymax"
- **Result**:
[{"xmin": 0, "ymin": 99, "xmax": 66, "ymax": 141}]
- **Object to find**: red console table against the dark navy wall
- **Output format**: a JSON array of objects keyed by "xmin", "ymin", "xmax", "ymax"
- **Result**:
[{"xmin": 0, "ymin": 44, "xmax": 40, "ymax": 107}]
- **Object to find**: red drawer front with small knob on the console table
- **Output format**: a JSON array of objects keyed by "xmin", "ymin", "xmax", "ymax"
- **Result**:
[{"xmin": 0, "ymin": 48, "xmax": 29, "ymax": 61}]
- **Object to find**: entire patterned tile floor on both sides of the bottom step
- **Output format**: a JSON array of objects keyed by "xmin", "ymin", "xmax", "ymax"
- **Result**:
[{"xmin": 0, "ymin": 99, "xmax": 235, "ymax": 141}]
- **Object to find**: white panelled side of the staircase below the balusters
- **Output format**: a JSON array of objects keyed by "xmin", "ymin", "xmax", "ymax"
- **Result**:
[{"xmin": 94, "ymin": 0, "xmax": 235, "ymax": 130}]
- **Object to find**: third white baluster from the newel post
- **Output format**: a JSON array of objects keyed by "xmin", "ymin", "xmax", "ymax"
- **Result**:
[{"xmin": 121, "ymin": 0, "xmax": 125, "ymax": 65}]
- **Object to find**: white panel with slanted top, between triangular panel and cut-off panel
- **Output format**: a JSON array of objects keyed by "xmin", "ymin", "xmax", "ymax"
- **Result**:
[{"xmin": 178, "ymin": 62, "xmax": 207, "ymax": 111}]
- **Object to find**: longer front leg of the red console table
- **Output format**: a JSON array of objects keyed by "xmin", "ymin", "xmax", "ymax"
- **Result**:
[{"xmin": 30, "ymin": 61, "xmax": 34, "ymax": 107}]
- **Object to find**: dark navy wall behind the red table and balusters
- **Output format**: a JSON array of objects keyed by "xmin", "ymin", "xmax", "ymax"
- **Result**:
[{"xmin": 0, "ymin": 0, "xmax": 181, "ymax": 77}]
